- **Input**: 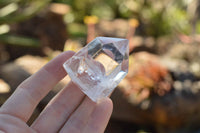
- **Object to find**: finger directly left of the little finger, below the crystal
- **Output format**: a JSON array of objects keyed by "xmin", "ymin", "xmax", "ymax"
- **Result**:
[{"xmin": 59, "ymin": 97, "xmax": 96, "ymax": 133}]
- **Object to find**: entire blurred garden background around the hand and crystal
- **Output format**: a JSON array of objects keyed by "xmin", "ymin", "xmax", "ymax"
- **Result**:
[{"xmin": 0, "ymin": 0, "xmax": 200, "ymax": 133}]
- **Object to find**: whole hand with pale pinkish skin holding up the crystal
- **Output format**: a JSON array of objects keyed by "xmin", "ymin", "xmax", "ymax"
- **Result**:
[{"xmin": 0, "ymin": 51, "xmax": 112, "ymax": 133}]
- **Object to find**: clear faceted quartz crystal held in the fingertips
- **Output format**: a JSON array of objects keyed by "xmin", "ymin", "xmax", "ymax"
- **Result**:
[{"xmin": 63, "ymin": 37, "xmax": 129, "ymax": 102}]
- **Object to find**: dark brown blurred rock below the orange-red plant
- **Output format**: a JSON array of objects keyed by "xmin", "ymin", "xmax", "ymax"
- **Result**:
[{"xmin": 111, "ymin": 86, "xmax": 200, "ymax": 133}]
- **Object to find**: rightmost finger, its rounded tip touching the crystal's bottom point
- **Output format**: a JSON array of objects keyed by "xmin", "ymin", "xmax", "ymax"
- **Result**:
[{"xmin": 83, "ymin": 98, "xmax": 113, "ymax": 133}]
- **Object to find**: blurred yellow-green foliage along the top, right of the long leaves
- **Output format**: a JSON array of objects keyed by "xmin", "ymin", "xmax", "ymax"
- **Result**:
[{"xmin": 54, "ymin": 0, "xmax": 191, "ymax": 37}]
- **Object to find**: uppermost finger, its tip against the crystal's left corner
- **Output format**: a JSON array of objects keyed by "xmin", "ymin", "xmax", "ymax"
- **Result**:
[{"xmin": 0, "ymin": 51, "xmax": 74, "ymax": 122}]
